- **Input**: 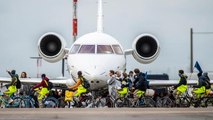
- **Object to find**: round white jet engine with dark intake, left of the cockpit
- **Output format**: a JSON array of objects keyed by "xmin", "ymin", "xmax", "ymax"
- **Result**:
[{"xmin": 38, "ymin": 32, "xmax": 66, "ymax": 63}]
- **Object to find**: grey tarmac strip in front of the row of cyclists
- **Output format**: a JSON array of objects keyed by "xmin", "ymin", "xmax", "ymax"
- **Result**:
[{"xmin": 0, "ymin": 108, "xmax": 213, "ymax": 120}]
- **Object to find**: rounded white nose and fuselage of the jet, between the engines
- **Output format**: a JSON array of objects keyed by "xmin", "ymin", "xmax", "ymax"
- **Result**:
[{"xmin": 67, "ymin": 32, "xmax": 126, "ymax": 89}]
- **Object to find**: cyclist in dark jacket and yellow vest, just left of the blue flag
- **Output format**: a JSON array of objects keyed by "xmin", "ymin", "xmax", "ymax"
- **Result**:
[{"xmin": 174, "ymin": 70, "xmax": 188, "ymax": 97}]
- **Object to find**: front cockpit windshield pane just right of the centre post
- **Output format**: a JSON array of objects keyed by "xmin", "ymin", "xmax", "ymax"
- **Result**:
[{"xmin": 97, "ymin": 45, "xmax": 113, "ymax": 54}]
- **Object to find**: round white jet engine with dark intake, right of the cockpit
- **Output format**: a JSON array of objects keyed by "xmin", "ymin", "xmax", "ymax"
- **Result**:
[{"xmin": 132, "ymin": 34, "xmax": 160, "ymax": 64}]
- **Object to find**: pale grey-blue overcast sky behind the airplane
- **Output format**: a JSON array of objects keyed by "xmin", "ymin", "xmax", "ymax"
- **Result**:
[{"xmin": 0, "ymin": 0, "xmax": 213, "ymax": 79}]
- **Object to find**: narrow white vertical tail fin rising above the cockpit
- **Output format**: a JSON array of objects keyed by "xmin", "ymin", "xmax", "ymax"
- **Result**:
[{"xmin": 97, "ymin": 0, "xmax": 104, "ymax": 32}]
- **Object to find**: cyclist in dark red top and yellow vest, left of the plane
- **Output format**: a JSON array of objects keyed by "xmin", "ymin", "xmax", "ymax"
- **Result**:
[{"xmin": 32, "ymin": 74, "xmax": 49, "ymax": 107}]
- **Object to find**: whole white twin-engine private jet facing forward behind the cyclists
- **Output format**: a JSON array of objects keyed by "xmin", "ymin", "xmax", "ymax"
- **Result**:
[{"xmin": 0, "ymin": 0, "xmax": 211, "ymax": 90}]
